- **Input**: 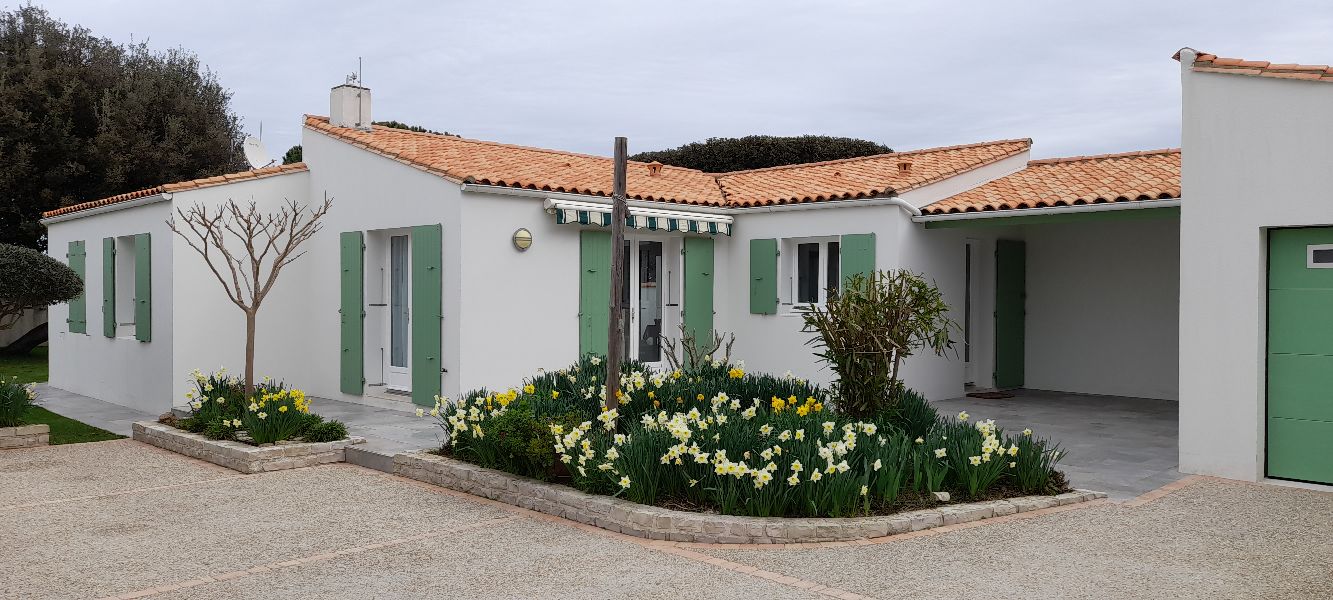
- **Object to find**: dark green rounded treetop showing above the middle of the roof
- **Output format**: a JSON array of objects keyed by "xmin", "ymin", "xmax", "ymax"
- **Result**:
[{"xmin": 629, "ymin": 136, "xmax": 893, "ymax": 173}]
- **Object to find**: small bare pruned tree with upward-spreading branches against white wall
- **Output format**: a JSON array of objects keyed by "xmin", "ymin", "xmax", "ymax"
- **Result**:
[{"xmin": 167, "ymin": 195, "xmax": 333, "ymax": 395}]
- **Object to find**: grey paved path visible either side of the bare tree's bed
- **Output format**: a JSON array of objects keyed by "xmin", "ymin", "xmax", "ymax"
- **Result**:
[{"xmin": 37, "ymin": 384, "xmax": 440, "ymax": 452}]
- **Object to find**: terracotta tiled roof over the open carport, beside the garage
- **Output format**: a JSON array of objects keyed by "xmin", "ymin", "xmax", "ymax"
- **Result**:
[{"xmin": 921, "ymin": 149, "xmax": 1180, "ymax": 215}]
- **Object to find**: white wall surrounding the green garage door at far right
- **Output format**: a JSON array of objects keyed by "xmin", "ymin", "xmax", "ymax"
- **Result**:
[{"xmin": 1180, "ymin": 52, "xmax": 1333, "ymax": 480}]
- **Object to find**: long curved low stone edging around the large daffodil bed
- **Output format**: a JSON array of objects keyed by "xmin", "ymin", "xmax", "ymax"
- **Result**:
[{"xmin": 393, "ymin": 452, "xmax": 1106, "ymax": 544}]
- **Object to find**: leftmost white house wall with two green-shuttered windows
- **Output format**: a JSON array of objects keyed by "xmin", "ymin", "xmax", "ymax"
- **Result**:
[{"xmin": 47, "ymin": 201, "xmax": 173, "ymax": 412}]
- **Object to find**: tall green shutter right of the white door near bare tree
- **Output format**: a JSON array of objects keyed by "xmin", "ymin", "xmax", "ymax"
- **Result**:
[{"xmin": 411, "ymin": 225, "xmax": 444, "ymax": 407}]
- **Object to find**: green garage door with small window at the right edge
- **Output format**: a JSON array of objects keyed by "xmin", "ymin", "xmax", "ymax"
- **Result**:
[{"xmin": 1268, "ymin": 227, "xmax": 1333, "ymax": 484}]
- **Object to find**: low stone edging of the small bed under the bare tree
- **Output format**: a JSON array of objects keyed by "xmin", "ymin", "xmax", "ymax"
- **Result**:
[{"xmin": 133, "ymin": 421, "xmax": 365, "ymax": 473}]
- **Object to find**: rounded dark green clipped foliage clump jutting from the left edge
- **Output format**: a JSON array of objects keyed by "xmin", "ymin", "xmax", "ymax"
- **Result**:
[{"xmin": 0, "ymin": 244, "xmax": 83, "ymax": 329}]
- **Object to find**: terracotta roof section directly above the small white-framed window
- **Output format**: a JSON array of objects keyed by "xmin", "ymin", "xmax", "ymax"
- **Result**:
[{"xmin": 717, "ymin": 140, "xmax": 1032, "ymax": 207}]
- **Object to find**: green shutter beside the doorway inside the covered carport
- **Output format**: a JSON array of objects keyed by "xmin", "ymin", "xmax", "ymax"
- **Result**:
[{"xmin": 994, "ymin": 240, "xmax": 1028, "ymax": 388}]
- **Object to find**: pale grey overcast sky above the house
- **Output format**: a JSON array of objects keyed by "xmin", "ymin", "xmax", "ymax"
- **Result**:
[{"xmin": 31, "ymin": 0, "xmax": 1333, "ymax": 157}]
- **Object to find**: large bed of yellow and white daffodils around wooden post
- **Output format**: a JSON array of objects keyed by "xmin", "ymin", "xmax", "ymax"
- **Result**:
[{"xmin": 431, "ymin": 356, "xmax": 1068, "ymax": 517}]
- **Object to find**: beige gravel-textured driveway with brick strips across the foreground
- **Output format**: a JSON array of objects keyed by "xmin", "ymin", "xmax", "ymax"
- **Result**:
[{"xmin": 0, "ymin": 440, "xmax": 1333, "ymax": 600}]
